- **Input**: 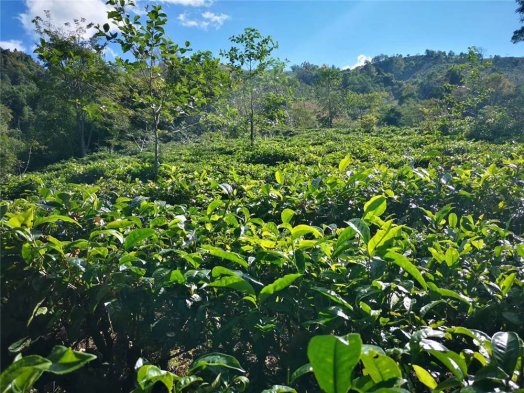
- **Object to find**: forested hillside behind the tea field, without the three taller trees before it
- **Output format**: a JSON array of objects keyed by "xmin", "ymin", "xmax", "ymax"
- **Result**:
[{"xmin": 0, "ymin": 43, "xmax": 524, "ymax": 176}]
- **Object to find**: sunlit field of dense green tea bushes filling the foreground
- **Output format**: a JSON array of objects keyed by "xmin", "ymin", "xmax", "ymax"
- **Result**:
[{"xmin": 0, "ymin": 129, "xmax": 524, "ymax": 392}]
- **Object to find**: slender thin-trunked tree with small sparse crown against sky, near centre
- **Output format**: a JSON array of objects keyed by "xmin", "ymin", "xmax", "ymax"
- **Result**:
[{"xmin": 220, "ymin": 27, "xmax": 278, "ymax": 146}]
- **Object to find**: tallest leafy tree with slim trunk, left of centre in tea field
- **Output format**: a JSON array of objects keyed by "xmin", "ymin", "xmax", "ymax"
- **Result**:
[{"xmin": 98, "ymin": 0, "xmax": 224, "ymax": 178}]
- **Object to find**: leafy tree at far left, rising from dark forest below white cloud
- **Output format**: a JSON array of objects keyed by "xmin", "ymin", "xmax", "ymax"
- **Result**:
[{"xmin": 33, "ymin": 12, "xmax": 110, "ymax": 156}]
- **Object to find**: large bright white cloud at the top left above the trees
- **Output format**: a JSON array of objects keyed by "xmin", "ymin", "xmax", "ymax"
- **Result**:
[{"xmin": 18, "ymin": 0, "xmax": 109, "ymax": 35}]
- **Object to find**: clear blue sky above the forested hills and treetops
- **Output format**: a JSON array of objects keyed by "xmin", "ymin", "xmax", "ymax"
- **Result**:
[{"xmin": 0, "ymin": 0, "xmax": 524, "ymax": 67}]
